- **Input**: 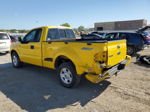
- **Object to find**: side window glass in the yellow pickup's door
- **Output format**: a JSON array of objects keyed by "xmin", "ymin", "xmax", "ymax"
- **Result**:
[{"xmin": 23, "ymin": 29, "xmax": 42, "ymax": 42}]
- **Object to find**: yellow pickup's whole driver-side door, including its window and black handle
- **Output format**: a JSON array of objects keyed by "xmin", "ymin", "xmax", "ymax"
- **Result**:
[{"xmin": 19, "ymin": 29, "xmax": 42, "ymax": 66}]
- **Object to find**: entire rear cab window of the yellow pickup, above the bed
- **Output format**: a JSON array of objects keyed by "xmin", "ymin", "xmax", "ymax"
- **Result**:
[{"xmin": 47, "ymin": 28, "xmax": 75, "ymax": 40}]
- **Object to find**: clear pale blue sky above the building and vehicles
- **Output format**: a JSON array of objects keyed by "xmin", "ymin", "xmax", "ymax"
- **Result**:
[{"xmin": 0, "ymin": 0, "xmax": 150, "ymax": 29}]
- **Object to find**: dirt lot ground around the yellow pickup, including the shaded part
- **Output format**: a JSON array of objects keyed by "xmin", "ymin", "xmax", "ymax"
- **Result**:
[{"xmin": 0, "ymin": 49, "xmax": 150, "ymax": 112}]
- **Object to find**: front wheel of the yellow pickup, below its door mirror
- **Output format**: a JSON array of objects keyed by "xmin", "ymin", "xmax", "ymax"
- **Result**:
[{"xmin": 11, "ymin": 52, "xmax": 23, "ymax": 68}]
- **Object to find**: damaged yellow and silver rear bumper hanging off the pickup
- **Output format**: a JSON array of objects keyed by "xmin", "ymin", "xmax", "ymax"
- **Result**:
[{"xmin": 85, "ymin": 56, "xmax": 131, "ymax": 83}]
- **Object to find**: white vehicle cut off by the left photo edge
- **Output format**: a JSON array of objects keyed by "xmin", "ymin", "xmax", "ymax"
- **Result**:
[{"xmin": 0, "ymin": 32, "xmax": 11, "ymax": 53}]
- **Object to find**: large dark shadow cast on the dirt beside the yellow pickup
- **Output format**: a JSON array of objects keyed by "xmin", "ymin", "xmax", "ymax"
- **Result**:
[{"xmin": 0, "ymin": 65, "xmax": 111, "ymax": 112}]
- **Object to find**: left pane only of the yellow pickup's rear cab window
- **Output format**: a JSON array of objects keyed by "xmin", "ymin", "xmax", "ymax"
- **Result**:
[{"xmin": 47, "ymin": 29, "xmax": 60, "ymax": 40}]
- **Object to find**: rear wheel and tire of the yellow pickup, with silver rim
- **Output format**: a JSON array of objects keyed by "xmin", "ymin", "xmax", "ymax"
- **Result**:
[{"xmin": 57, "ymin": 62, "xmax": 81, "ymax": 88}]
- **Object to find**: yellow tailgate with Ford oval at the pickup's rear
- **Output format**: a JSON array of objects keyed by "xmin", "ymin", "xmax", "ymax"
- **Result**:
[{"xmin": 107, "ymin": 40, "xmax": 126, "ymax": 67}]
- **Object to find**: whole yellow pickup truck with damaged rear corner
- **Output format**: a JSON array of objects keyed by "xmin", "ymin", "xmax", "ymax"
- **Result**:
[{"xmin": 11, "ymin": 26, "xmax": 131, "ymax": 88}]
